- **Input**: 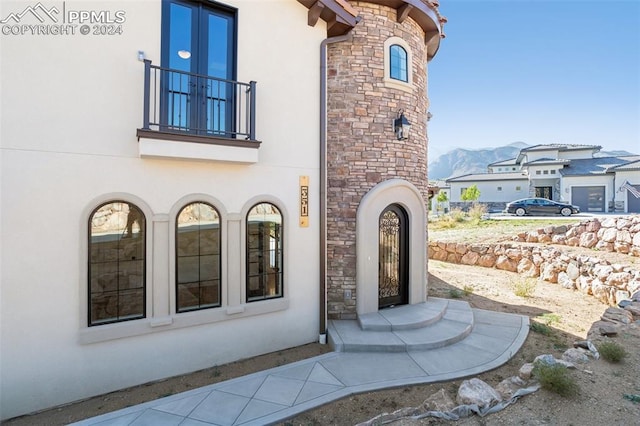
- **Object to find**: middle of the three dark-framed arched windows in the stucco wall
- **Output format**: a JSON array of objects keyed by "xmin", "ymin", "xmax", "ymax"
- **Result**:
[{"xmin": 176, "ymin": 202, "xmax": 220, "ymax": 312}]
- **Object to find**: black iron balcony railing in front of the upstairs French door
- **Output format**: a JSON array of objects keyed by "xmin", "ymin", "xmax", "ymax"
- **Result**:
[{"xmin": 143, "ymin": 59, "xmax": 256, "ymax": 141}]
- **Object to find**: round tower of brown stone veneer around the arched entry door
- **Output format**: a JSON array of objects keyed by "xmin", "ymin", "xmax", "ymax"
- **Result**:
[{"xmin": 326, "ymin": 0, "xmax": 444, "ymax": 319}]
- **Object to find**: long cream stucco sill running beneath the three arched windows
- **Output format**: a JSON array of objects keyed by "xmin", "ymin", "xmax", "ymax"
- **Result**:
[{"xmin": 78, "ymin": 298, "xmax": 289, "ymax": 345}]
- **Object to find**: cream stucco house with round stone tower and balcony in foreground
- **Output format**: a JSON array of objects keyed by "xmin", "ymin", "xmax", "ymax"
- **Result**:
[{"xmin": 0, "ymin": 0, "xmax": 445, "ymax": 419}]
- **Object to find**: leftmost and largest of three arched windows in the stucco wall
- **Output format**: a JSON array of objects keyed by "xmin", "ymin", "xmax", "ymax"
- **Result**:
[{"xmin": 89, "ymin": 201, "xmax": 146, "ymax": 326}]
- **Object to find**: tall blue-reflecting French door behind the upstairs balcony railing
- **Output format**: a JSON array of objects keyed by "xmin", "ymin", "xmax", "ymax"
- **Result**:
[{"xmin": 161, "ymin": 0, "xmax": 236, "ymax": 137}]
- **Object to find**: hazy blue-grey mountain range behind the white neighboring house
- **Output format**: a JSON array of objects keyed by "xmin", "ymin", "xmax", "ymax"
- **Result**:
[{"xmin": 429, "ymin": 142, "xmax": 633, "ymax": 180}]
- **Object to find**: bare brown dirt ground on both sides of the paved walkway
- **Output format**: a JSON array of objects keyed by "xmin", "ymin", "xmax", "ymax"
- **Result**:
[{"xmin": 3, "ymin": 218, "xmax": 640, "ymax": 426}]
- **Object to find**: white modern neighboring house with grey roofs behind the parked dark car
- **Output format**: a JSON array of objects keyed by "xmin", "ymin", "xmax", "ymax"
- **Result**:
[{"xmin": 447, "ymin": 144, "xmax": 640, "ymax": 213}]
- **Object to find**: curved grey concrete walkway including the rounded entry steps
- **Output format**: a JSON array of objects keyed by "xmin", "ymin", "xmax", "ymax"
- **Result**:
[{"xmin": 75, "ymin": 298, "xmax": 529, "ymax": 426}]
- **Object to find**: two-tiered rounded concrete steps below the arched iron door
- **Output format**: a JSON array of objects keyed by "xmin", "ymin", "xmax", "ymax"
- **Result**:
[{"xmin": 328, "ymin": 297, "xmax": 474, "ymax": 352}]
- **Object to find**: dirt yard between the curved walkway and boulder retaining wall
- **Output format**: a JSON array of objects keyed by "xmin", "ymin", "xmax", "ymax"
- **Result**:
[{"xmin": 284, "ymin": 261, "xmax": 640, "ymax": 426}]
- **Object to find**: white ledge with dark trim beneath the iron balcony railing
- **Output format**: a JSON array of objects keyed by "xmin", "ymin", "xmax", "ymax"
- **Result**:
[{"xmin": 136, "ymin": 129, "xmax": 261, "ymax": 164}]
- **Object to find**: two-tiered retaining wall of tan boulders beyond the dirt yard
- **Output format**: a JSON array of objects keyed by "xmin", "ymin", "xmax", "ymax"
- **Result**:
[{"xmin": 429, "ymin": 216, "xmax": 640, "ymax": 305}]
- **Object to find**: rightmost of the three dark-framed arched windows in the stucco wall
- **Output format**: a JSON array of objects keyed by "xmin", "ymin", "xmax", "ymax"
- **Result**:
[{"xmin": 247, "ymin": 203, "xmax": 283, "ymax": 302}]
